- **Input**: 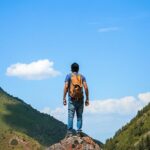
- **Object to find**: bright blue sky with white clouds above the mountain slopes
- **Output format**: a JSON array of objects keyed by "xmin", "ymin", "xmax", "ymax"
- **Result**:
[{"xmin": 0, "ymin": 0, "xmax": 150, "ymax": 142}]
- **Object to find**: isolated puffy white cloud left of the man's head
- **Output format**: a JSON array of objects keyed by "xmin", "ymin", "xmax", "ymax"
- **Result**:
[{"xmin": 6, "ymin": 59, "xmax": 60, "ymax": 80}]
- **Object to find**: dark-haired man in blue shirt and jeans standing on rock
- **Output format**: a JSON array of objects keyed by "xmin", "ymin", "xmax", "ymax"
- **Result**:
[{"xmin": 63, "ymin": 63, "xmax": 89, "ymax": 137}]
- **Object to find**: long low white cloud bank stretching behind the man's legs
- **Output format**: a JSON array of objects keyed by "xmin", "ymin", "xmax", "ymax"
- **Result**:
[{"xmin": 42, "ymin": 92, "xmax": 150, "ymax": 118}]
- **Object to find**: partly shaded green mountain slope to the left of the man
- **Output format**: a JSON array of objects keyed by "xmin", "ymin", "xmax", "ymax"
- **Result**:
[{"xmin": 0, "ymin": 88, "xmax": 66, "ymax": 150}]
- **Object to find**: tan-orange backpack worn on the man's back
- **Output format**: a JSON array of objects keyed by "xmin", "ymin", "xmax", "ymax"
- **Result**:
[{"xmin": 70, "ymin": 73, "xmax": 83, "ymax": 99}]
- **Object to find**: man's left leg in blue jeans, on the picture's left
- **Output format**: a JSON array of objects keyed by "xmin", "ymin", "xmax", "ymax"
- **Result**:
[{"xmin": 68, "ymin": 100, "xmax": 75, "ymax": 133}]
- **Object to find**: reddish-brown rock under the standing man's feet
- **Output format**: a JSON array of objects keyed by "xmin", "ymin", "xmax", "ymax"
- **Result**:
[{"xmin": 46, "ymin": 136, "xmax": 102, "ymax": 150}]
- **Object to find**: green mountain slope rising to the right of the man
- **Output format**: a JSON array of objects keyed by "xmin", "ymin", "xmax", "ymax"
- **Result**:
[{"xmin": 105, "ymin": 103, "xmax": 150, "ymax": 150}]
